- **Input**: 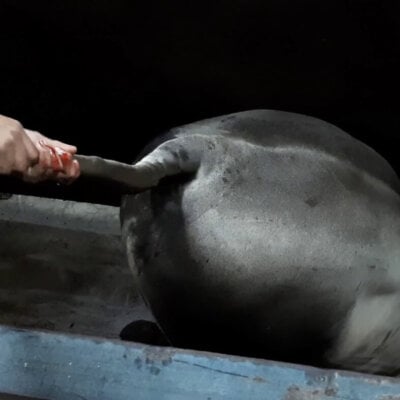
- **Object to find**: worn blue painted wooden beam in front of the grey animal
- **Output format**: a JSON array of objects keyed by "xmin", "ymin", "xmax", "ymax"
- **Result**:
[{"xmin": 0, "ymin": 327, "xmax": 400, "ymax": 400}]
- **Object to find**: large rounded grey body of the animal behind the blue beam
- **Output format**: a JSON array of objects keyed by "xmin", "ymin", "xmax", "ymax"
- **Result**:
[{"xmin": 121, "ymin": 110, "xmax": 400, "ymax": 374}]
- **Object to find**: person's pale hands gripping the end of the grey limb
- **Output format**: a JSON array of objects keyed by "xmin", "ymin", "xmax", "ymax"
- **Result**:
[{"xmin": 0, "ymin": 115, "xmax": 79, "ymax": 182}]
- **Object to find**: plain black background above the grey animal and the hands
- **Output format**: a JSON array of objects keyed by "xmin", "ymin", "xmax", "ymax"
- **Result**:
[{"xmin": 0, "ymin": 0, "xmax": 400, "ymax": 202}]
